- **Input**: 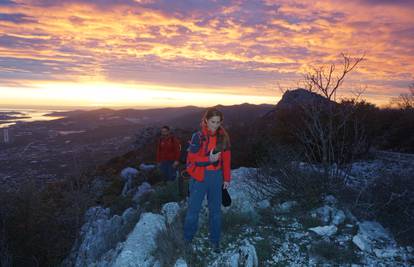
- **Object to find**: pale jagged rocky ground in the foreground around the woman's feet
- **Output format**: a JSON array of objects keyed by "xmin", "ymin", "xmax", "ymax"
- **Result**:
[{"xmin": 62, "ymin": 168, "xmax": 413, "ymax": 267}]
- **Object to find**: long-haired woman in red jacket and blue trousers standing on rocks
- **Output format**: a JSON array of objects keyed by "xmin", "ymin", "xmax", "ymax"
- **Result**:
[{"xmin": 184, "ymin": 108, "xmax": 231, "ymax": 252}]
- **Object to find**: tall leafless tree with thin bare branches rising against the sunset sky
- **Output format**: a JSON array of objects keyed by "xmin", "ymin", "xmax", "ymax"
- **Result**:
[{"xmin": 278, "ymin": 54, "xmax": 368, "ymax": 184}]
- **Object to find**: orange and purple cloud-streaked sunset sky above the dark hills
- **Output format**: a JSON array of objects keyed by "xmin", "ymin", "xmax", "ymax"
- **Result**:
[{"xmin": 0, "ymin": 0, "xmax": 414, "ymax": 107}]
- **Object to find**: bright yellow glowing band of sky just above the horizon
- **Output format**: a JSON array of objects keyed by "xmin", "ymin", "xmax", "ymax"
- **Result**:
[{"xmin": 0, "ymin": 82, "xmax": 278, "ymax": 108}]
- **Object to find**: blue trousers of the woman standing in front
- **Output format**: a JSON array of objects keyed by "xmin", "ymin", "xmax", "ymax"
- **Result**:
[{"xmin": 184, "ymin": 170, "xmax": 223, "ymax": 243}]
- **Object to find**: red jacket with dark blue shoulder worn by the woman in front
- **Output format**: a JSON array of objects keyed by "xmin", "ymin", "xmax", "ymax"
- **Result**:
[{"xmin": 187, "ymin": 126, "xmax": 231, "ymax": 182}]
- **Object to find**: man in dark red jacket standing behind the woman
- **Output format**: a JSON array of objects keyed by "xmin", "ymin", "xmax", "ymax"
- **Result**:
[{"xmin": 157, "ymin": 126, "xmax": 181, "ymax": 181}]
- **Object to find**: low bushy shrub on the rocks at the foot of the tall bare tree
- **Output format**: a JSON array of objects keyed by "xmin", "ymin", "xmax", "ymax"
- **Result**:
[{"xmin": 249, "ymin": 146, "xmax": 345, "ymax": 206}]
